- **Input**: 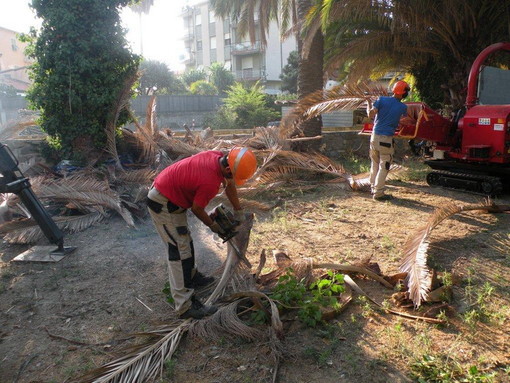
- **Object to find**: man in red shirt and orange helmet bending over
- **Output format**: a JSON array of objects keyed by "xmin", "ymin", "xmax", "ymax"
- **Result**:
[{"xmin": 147, "ymin": 147, "xmax": 257, "ymax": 319}]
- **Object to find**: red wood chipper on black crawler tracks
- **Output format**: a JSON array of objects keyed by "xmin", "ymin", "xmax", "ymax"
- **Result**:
[{"xmin": 362, "ymin": 42, "xmax": 510, "ymax": 195}]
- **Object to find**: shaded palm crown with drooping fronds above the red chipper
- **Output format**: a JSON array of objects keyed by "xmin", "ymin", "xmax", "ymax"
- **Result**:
[{"xmin": 304, "ymin": 0, "xmax": 510, "ymax": 109}]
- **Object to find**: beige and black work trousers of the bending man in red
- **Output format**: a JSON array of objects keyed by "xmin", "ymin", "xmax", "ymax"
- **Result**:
[{"xmin": 148, "ymin": 187, "xmax": 196, "ymax": 315}]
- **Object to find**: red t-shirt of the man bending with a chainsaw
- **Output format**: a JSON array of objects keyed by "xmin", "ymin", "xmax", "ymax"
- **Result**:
[{"xmin": 154, "ymin": 150, "xmax": 224, "ymax": 209}]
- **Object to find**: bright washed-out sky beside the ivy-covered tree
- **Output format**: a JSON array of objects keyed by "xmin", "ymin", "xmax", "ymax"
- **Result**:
[{"xmin": 0, "ymin": 0, "xmax": 191, "ymax": 71}]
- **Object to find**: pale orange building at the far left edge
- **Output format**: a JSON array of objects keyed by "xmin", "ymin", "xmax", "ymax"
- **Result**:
[{"xmin": 0, "ymin": 27, "xmax": 31, "ymax": 93}]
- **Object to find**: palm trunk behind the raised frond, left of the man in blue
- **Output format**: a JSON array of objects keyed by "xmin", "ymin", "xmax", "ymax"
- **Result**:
[{"xmin": 297, "ymin": 0, "xmax": 324, "ymax": 150}]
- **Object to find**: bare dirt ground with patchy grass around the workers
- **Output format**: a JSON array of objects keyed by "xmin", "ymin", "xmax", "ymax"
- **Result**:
[{"xmin": 0, "ymin": 169, "xmax": 510, "ymax": 383}]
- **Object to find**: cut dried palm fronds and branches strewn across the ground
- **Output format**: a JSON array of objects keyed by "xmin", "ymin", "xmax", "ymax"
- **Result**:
[{"xmin": 0, "ymin": 96, "xmax": 510, "ymax": 383}]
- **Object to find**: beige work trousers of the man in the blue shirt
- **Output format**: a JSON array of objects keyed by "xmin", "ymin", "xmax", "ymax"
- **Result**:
[{"xmin": 370, "ymin": 133, "xmax": 395, "ymax": 198}]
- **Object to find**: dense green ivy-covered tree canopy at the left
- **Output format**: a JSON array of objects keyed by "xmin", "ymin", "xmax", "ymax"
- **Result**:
[{"xmin": 24, "ymin": 0, "xmax": 139, "ymax": 158}]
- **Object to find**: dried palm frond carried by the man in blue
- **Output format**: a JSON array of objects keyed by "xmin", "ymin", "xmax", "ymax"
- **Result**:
[{"xmin": 280, "ymin": 82, "xmax": 388, "ymax": 137}]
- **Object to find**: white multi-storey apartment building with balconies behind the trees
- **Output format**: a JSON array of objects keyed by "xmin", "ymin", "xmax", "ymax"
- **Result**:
[{"xmin": 181, "ymin": 1, "xmax": 297, "ymax": 94}]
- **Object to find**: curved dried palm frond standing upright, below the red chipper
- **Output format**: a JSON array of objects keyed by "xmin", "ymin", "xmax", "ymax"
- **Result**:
[{"xmin": 400, "ymin": 202, "xmax": 494, "ymax": 307}]
